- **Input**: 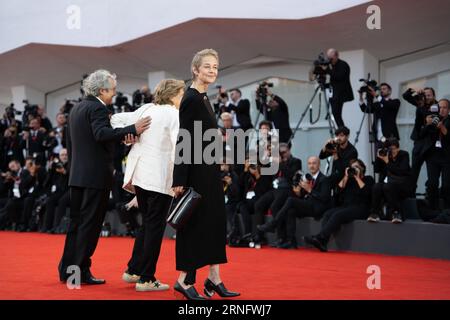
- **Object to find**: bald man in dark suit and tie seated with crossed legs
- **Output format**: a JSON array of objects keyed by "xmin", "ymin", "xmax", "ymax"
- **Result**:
[{"xmin": 258, "ymin": 157, "xmax": 331, "ymax": 249}]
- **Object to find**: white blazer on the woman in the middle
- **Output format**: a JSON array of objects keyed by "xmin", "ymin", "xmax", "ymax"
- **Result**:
[{"xmin": 111, "ymin": 103, "xmax": 180, "ymax": 196}]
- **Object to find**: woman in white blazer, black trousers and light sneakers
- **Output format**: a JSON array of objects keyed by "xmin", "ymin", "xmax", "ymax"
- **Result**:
[{"xmin": 111, "ymin": 79, "xmax": 185, "ymax": 291}]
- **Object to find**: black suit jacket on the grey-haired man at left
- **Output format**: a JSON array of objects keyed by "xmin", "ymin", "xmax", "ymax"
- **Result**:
[{"xmin": 67, "ymin": 96, "xmax": 136, "ymax": 189}]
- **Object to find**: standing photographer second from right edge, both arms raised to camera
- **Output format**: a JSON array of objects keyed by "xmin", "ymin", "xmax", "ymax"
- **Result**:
[{"xmin": 403, "ymin": 87, "xmax": 437, "ymax": 197}]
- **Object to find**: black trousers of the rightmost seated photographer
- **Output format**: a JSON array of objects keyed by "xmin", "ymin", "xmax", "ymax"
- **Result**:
[{"xmin": 372, "ymin": 182, "xmax": 410, "ymax": 216}]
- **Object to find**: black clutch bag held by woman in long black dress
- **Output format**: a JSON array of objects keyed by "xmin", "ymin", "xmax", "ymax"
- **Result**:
[{"xmin": 167, "ymin": 188, "xmax": 202, "ymax": 229}]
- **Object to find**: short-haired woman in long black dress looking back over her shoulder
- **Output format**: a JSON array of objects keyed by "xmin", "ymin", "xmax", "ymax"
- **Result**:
[{"xmin": 173, "ymin": 49, "xmax": 239, "ymax": 300}]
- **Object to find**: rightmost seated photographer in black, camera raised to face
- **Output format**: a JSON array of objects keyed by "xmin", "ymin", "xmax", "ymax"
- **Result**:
[{"xmin": 367, "ymin": 138, "xmax": 411, "ymax": 223}]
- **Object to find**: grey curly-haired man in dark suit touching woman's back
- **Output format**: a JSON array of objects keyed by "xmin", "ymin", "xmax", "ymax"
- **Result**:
[{"xmin": 59, "ymin": 70, "xmax": 150, "ymax": 284}]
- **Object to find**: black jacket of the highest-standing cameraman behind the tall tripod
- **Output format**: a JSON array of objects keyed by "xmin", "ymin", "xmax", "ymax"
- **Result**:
[{"xmin": 328, "ymin": 59, "xmax": 354, "ymax": 102}]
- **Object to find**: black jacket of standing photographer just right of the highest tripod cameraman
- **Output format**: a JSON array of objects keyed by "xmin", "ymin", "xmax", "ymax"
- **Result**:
[{"xmin": 359, "ymin": 98, "xmax": 400, "ymax": 140}]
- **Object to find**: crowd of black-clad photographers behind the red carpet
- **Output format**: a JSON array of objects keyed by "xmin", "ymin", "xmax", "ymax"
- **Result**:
[{"xmin": 0, "ymin": 61, "xmax": 450, "ymax": 251}]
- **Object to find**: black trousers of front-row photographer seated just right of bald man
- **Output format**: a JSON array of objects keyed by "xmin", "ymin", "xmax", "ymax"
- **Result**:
[{"xmin": 319, "ymin": 205, "xmax": 369, "ymax": 242}]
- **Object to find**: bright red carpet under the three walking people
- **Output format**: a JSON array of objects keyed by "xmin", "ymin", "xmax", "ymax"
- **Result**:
[{"xmin": 0, "ymin": 232, "xmax": 450, "ymax": 300}]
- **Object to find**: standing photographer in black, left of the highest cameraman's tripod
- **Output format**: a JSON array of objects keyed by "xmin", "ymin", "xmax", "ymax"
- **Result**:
[{"xmin": 256, "ymin": 82, "xmax": 292, "ymax": 143}]
